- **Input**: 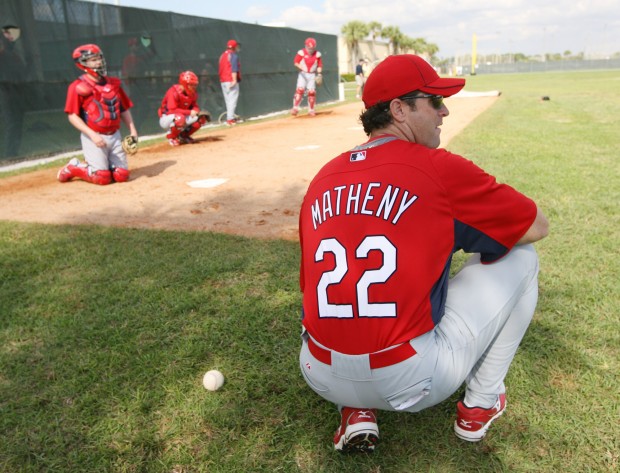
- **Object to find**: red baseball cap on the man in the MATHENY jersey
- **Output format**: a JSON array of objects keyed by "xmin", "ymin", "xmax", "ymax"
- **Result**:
[{"xmin": 362, "ymin": 54, "xmax": 465, "ymax": 108}]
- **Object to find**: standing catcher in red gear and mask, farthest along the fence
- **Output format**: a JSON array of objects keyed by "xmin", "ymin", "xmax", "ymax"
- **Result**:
[{"xmin": 291, "ymin": 38, "xmax": 323, "ymax": 117}]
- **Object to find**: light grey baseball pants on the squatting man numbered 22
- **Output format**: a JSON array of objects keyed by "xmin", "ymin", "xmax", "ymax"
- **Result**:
[{"xmin": 300, "ymin": 245, "xmax": 538, "ymax": 412}]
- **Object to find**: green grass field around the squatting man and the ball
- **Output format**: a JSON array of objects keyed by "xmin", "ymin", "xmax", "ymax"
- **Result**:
[{"xmin": 0, "ymin": 71, "xmax": 620, "ymax": 473}]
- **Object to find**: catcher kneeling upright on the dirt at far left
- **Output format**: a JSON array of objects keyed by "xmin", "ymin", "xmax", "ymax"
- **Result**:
[{"xmin": 57, "ymin": 44, "xmax": 138, "ymax": 185}]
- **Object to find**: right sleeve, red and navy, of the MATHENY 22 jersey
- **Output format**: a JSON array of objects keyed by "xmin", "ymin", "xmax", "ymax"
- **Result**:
[{"xmin": 435, "ymin": 151, "xmax": 536, "ymax": 263}]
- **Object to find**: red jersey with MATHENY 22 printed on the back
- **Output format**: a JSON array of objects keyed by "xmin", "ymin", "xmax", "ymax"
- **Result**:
[{"xmin": 299, "ymin": 135, "xmax": 536, "ymax": 355}]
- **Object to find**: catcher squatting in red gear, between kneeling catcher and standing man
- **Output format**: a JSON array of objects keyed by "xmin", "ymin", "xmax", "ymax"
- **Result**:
[{"xmin": 157, "ymin": 71, "xmax": 206, "ymax": 146}]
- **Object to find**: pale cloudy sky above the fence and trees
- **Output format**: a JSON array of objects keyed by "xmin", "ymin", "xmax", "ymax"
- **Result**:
[{"xmin": 91, "ymin": 0, "xmax": 620, "ymax": 57}]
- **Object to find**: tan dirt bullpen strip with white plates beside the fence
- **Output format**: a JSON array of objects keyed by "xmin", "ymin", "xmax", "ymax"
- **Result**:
[{"xmin": 0, "ymin": 97, "xmax": 497, "ymax": 240}]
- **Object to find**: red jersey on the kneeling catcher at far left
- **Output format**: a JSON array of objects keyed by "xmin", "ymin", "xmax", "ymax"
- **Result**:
[{"xmin": 65, "ymin": 74, "xmax": 133, "ymax": 134}]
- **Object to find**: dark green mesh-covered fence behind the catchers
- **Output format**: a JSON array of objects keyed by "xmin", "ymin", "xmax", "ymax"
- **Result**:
[{"xmin": 0, "ymin": 0, "xmax": 338, "ymax": 161}]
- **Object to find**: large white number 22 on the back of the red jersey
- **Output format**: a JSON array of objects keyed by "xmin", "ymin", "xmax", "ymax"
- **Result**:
[{"xmin": 314, "ymin": 236, "xmax": 396, "ymax": 319}]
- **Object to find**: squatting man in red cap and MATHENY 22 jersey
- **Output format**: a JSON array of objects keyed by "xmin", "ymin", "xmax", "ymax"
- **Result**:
[{"xmin": 299, "ymin": 55, "xmax": 548, "ymax": 451}]
